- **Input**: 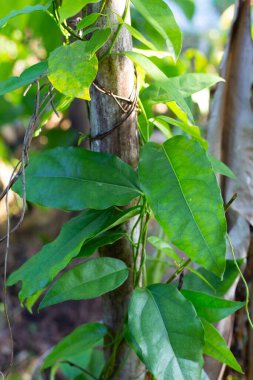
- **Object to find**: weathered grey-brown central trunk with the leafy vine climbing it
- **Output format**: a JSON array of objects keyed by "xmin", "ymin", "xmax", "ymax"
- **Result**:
[{"xmin": 89, "ymin": 0, "xmax": 145, "ymax": 380}]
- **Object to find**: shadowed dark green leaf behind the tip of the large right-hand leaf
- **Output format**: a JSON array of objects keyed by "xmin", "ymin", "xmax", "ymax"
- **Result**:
[{"xmin": 183, "ymin": 260, "xmax": 243, "ymax": 297}]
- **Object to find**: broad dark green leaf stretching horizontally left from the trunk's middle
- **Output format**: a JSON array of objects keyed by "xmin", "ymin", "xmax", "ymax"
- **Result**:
[{"xmin": 14, "ymin": 147, "xmax": 141, "ymax": 210}]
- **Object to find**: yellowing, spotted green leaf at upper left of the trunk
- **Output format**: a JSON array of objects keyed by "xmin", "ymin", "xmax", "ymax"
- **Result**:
[{"xmin": 48, "ymin": 28, "xmax": 111, "ymax": 100}]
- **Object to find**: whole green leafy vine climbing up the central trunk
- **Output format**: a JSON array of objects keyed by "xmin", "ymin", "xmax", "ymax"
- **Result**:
[{"xmin": 0, "ymin": 0, "xmax": 247, "ymax": 380}]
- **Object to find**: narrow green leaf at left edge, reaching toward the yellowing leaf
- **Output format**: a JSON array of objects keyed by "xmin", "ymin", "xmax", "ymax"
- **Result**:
[{"xmin": 0, "ymin": 61, "xmax": 48, "ymax": 95}]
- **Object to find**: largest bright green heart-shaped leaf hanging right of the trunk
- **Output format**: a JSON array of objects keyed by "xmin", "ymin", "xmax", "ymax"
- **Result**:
[{"xmin": 139, "ymin": 136, "xmax": 226, "ymax": 276}]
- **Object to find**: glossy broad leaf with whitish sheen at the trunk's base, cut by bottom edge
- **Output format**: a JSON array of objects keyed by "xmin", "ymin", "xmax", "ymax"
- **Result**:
[{"xmin": 128, "ymin": 284, "xmax": 204, "ymax": 380}]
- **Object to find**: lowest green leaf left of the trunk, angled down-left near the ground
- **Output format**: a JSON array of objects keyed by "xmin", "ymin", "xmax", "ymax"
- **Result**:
[{"xmin": 42, "ymin": 323, "xmax": 108, "ymax": 369}]
